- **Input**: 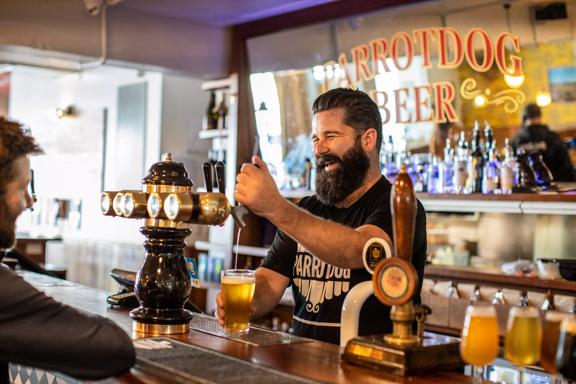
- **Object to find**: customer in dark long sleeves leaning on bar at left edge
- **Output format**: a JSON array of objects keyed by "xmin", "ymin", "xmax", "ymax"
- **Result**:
[{"xmin": 0, "ymin": 117, "xmax": 135, "ymax": 383}]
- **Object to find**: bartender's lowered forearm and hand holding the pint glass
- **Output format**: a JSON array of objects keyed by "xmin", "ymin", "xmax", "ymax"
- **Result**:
[{"xmin": 216, "ymin": 267, "xmax": 290, "ymax": 326}]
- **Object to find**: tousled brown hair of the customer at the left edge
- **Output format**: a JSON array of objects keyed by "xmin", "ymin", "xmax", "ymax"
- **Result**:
[{"xmin": 0, "ymin": 117, "xmax": 42, "ymax": 195}]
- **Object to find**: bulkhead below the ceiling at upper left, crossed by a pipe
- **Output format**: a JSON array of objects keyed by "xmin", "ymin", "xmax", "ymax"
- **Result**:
[{"xmin": 0, "ymin": 0, "xmax": 230, "ymax": 79}]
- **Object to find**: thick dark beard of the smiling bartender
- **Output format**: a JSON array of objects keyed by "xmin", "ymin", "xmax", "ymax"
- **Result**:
[{"xmin": 316, "ymin": 140, "xmax": 370, "ymax": 205}]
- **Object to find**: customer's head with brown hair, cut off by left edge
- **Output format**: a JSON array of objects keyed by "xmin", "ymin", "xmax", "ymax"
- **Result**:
[{"xmin": 0, "ymin": 117, "xmax": 42, "ymax": 249}]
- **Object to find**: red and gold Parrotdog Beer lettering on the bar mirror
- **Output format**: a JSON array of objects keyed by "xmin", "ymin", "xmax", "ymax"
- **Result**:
[{"xmin": 322, "ymin": 27, "xmax": 525, "ymax": 123}]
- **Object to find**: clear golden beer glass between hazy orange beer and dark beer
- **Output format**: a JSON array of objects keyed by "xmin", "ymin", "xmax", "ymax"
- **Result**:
[{"xmin": 504, "ymin": 307, "xmax": 542, "ymax": 366}]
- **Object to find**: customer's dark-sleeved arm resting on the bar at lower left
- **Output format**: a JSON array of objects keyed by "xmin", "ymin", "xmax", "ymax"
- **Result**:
[{"xmin": 0, "ymin": 266, "xmax": 135, "ymax": 380}]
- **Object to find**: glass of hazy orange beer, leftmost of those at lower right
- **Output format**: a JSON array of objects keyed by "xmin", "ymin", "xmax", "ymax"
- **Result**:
[{"xmin": 460, "ymin": 306, "xmax": 498, "ymax": 367}]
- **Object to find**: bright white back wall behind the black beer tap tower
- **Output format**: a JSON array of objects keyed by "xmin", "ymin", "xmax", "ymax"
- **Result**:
[{"xmin": 10, "ymin": 66, "xmax": 209, "ymax": 289}]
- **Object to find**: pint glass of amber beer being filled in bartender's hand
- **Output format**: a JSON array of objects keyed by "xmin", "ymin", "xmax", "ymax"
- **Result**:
[{"xmin": 221, "ymin": 269, "xmax": 256, "ymax": 333}]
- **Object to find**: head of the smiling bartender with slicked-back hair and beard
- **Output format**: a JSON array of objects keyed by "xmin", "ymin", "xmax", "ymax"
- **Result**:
[{"xmin": 312, "ymin": 88, "xmax": 382, "ymax": 205}]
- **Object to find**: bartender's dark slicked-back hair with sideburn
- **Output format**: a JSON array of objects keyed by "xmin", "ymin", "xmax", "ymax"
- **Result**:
[{"xmin": 312, "ymin": 88, "xmax": 382, "ymax": 153}]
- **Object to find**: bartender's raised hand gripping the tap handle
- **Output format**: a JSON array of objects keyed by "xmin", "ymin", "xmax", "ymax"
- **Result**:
[{"xmin": 234, "ymin": 156, "xmax": 284, "ymax": 217}]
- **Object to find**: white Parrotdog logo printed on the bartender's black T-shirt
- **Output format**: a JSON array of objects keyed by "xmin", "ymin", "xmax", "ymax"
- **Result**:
[{"xmin": 293, "ymin": 244, "xmax": 350, "ymax": 313}]
